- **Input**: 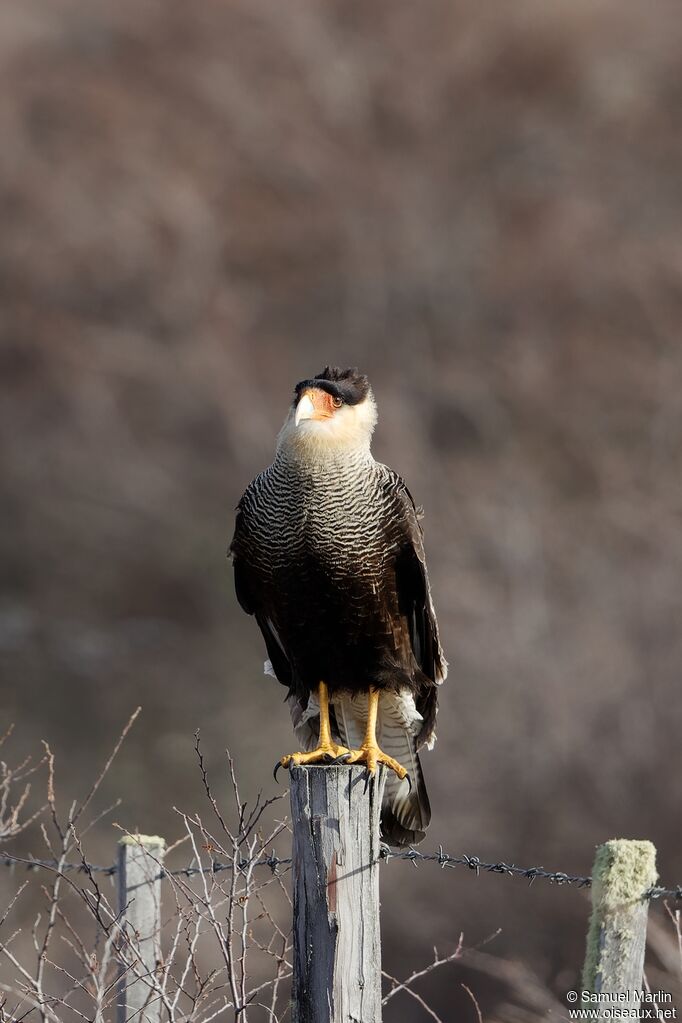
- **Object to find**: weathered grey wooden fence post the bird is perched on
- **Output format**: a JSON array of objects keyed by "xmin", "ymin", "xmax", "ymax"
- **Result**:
[{"xmin": 289, "ymin": 765, "xmax": 385, "ymax": 1023}]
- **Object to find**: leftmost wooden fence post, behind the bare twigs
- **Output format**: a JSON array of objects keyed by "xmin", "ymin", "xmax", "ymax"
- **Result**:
[{"xmin": 117, "ymin": 835, "xmax": 166, "ymax": 1023}]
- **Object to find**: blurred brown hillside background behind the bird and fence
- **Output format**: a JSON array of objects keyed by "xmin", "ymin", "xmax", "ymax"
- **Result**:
[{"xmin": 0, "ymin": 0, "xmax": 682, "ymax": 1021}]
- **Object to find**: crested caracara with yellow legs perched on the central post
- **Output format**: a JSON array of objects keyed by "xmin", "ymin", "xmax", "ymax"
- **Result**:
[{"xmin": 230, "ymin": 366, "xmax": 447, "ymax": 845}]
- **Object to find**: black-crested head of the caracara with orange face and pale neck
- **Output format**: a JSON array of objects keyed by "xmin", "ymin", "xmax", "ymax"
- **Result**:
[{"xmin": 278, "ymin": 366, "xmax": 376, "ymax": 458}]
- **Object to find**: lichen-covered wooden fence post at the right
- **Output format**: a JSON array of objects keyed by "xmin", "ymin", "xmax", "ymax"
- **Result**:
[{"xmin": 582, "ymin": 839, "xmax": 657, "ymax": 1020}]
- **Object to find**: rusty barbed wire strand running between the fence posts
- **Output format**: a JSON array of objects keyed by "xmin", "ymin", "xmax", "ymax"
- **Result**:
[{"xmin": 0, "ymin": 846, "xmax": 682, "ymax": 901}]
